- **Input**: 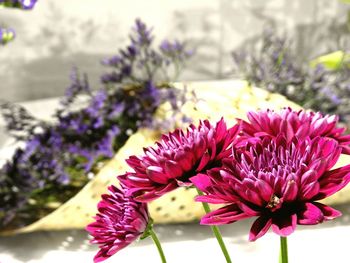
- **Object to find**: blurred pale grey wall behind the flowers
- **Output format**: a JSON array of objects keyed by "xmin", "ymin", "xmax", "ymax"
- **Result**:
[{"xmin": 0, "ymin": 0, "xmax": 349, "ymax": 102}]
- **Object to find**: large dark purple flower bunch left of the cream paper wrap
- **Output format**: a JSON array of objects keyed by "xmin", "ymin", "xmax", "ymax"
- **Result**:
[{"xmin": 0, "ymin": 20, "xmax": 194, "ymax": 232}]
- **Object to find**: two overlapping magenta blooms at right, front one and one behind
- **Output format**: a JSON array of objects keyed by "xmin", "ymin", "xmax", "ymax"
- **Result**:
[{"xmin": 192, "ymin": 109, "xmax": 350, "ymax": 241}]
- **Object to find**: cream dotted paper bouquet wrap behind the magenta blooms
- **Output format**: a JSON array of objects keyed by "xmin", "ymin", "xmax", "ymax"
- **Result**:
[{"xmin": 5, "ymin": 81, "xmax": 350, "ymax": 233}]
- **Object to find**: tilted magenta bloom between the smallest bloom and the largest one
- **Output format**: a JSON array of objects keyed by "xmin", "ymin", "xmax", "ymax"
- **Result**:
[{"xmin": 118, "ymin": 119, "xmax": 239, "ymax": 202}]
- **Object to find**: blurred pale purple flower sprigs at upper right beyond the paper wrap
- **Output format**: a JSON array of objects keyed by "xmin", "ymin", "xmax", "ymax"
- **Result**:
[{"xmin": 233, "ymin": 30, "xmax": 350, "ymax": 123}]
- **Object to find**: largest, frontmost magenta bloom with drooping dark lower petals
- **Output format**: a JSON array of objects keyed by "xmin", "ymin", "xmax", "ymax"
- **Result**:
[{"xmin": 191, "ymin": 136, "xmax": 350, "ymax": 241}]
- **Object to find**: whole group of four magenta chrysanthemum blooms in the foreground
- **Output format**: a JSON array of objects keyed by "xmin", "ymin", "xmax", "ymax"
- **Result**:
[{"xmin": 87, "ymin": 108, "xmax": 350, "ymax": 259}]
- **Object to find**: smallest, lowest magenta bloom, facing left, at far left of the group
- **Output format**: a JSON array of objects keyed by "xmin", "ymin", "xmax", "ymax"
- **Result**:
[{"xmin": 86, "ymin": 186, "xmax": 149, "ymax": 262}]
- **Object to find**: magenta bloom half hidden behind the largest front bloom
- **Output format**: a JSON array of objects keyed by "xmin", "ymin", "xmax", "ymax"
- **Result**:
[{"xmin": 239, "ymin": 108, "xmax": 350, "ymax": 154}]
